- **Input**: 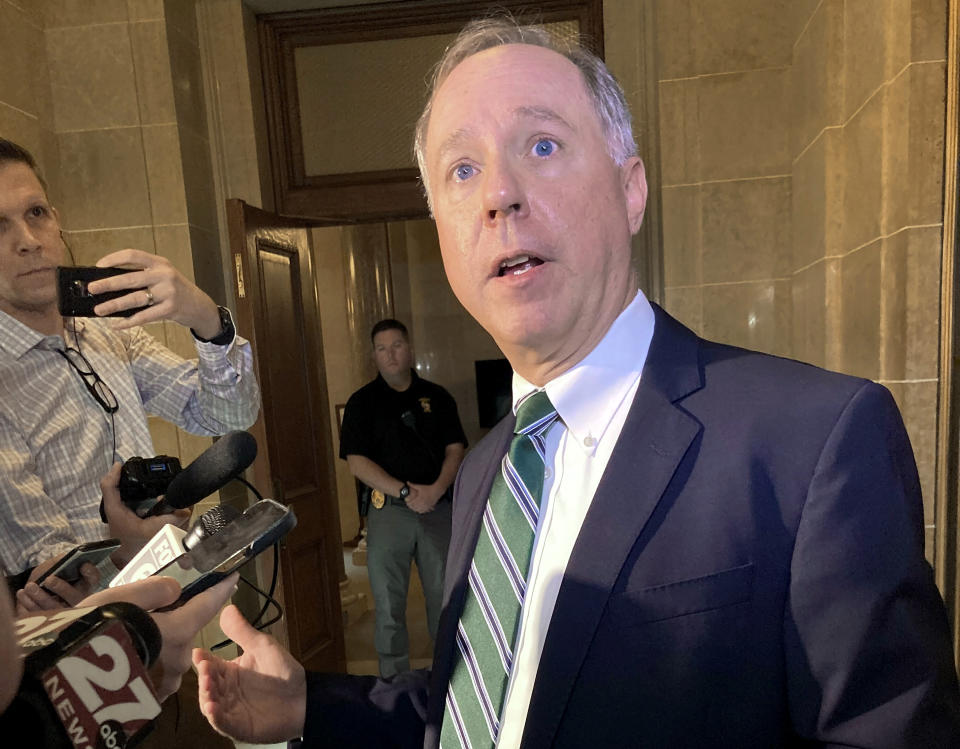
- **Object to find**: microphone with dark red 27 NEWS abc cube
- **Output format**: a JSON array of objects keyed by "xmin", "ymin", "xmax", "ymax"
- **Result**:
[{"xmin": 11, "ymin": 603, "xmax": 162, "ymax": 749}]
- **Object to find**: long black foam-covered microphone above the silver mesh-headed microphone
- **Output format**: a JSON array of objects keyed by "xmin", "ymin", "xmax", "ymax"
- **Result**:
[{"xmin": 145, "ymin": 431, "xmax": 257, "ymax": 517}]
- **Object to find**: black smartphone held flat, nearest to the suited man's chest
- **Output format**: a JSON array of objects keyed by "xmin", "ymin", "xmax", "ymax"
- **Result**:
[{"xmin": 153, "ymin": 499, "xmax": 297, "ymax": 611}]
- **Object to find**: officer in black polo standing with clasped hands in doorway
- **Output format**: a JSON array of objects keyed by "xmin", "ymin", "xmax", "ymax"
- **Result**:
[{"xmin": 340, "ymin": 319, "xmax": 467, "ymax": 678}]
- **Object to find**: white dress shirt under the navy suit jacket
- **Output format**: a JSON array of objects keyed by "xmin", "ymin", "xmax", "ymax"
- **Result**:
[{"xmin": 497, "ymin": 291, "xmax": 654, "ymax": 747}]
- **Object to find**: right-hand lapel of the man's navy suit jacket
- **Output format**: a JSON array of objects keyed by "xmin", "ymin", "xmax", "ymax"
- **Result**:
[{"xmin": 523, "ymin": 305, "xmax": 702, "ymax": 747}]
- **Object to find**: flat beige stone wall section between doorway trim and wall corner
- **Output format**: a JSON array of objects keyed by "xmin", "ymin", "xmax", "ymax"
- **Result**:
[{"xmin": 657, "ymin": 0, "xmax": 794, "ymax": 354}]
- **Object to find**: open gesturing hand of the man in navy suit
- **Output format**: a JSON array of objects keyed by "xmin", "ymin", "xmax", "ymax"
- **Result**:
[{"xmin": 193, "ymin": 606, "xmax": 307, "ymax": 743}]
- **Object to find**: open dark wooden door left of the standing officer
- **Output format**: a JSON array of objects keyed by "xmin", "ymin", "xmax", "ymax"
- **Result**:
[{"xmin": 227, "ymin": 200, "xmax": 346, "ymax": 671}]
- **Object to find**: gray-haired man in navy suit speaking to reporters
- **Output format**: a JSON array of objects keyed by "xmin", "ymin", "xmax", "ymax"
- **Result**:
[{"xmin": 189, "ymin": 14, "xmax": 960, "ymax": 749}]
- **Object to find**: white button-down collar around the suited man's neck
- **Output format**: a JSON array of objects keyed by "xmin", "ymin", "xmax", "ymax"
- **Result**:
[{"xmin": 513, "ymin": 290, "xmax": 654, "ymax": 455}]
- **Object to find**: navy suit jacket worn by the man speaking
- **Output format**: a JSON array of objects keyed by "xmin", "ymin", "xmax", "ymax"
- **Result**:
[{"xmin": 296, "ymin": 308, "xmax": 960, "ymax": 749}]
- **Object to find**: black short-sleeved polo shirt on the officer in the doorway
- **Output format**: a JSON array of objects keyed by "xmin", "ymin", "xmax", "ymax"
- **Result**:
[{"xmin": 340, "ymin": 370, "xmax": 467, "ymax": 484}]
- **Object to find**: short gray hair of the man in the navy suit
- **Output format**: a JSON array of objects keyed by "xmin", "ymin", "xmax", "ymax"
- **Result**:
[{"xmin": 413, "ymin": 15, "xmax": 637, "ymax": 213}]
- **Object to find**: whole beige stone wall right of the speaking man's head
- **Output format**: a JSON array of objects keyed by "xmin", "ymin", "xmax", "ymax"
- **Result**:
[{"xmin": 658, "ymin": 0, "xmax": 947, "ymax": 558}]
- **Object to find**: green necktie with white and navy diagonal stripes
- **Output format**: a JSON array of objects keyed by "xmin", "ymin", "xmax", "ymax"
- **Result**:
[{"xmin": 440, "ymin": 391, "xmax": 557, "ymax": 749}]
